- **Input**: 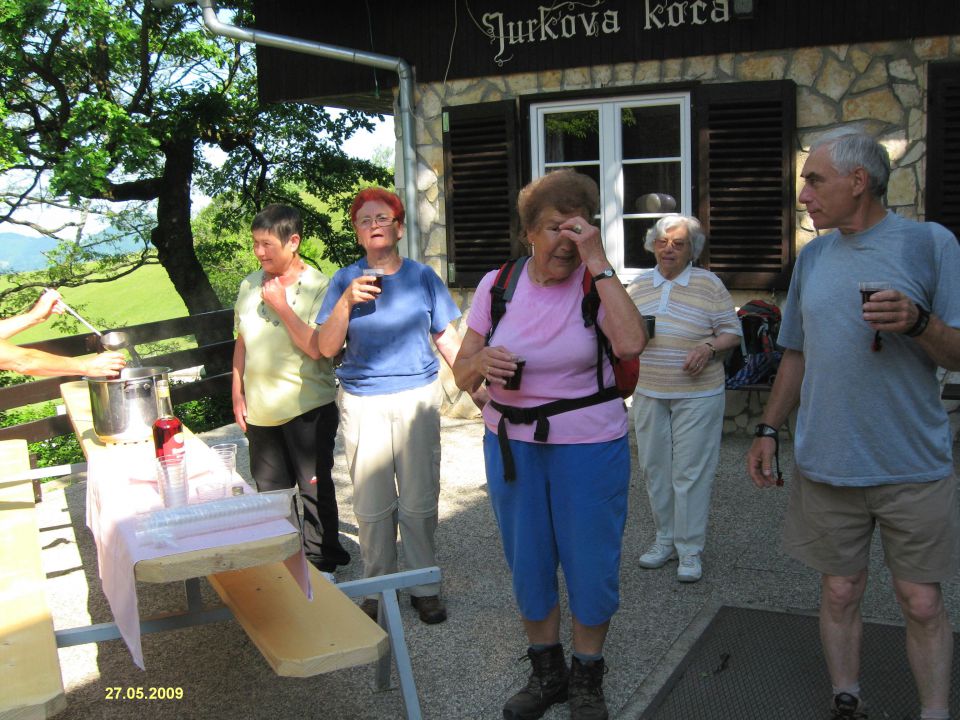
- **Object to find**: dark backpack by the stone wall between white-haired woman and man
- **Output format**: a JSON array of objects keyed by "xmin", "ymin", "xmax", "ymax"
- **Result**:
[{"xmin": 723, "ymin": 300, "xmax": 783, "ymax": 390}]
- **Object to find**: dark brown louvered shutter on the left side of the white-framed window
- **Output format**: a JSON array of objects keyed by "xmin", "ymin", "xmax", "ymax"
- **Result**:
[{"xmin": 443, "ymin": 100, "xmax": 521, "ymax": 288}]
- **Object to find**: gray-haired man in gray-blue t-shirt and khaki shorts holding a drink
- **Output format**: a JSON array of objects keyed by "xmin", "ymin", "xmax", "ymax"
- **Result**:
[{"xmin": 747, "ymin": 129, "xmax": 960, "ymax": 718}]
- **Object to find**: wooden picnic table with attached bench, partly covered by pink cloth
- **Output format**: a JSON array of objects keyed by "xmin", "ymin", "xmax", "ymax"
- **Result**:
[{"xmin": 58, "ymin": 381, "xmax": 389, "ymax": 677}]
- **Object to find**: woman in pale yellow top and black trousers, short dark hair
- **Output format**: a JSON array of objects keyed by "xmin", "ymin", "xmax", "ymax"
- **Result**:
[{"xmin": 233, "ymin": 205, "xmax": 350, "ymax": 572}]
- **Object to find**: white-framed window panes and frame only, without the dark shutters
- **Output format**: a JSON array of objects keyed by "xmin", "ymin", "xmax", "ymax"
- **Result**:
[{"xmin": 530, "ymin": 93, "xmax": 692, "ymax": 282}]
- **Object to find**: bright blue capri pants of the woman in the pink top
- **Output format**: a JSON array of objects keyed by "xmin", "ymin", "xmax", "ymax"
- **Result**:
[{"xmin": 483, "ymin": 430, "xmax": 630, "ymax": 626}]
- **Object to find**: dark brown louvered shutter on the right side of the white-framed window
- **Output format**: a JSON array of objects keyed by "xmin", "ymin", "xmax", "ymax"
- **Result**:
[{"xmin": 694, "ymin": 80, "xmax": 797, "ymax": 290}]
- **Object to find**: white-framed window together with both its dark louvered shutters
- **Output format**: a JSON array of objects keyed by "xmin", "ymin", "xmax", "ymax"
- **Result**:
[{"xmin": 443, "ymin": 80, "xmax": 796, "ymax": 290}]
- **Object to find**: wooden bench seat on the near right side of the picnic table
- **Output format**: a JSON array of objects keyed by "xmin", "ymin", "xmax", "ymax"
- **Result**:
[{"xmin": 207, "ymin": 563, "xmax": 390, "ymax": 677}]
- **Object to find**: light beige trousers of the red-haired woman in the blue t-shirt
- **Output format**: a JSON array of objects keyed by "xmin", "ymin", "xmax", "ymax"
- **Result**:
[{"xmin": 338, "ymin": 381, "xmax": 440, "ymax": 596}]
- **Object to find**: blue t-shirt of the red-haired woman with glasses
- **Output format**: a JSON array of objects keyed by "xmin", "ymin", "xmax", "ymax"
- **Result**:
[{"xmin": 317, "ymin": 258, "xmax": 460, "ymax": 395}]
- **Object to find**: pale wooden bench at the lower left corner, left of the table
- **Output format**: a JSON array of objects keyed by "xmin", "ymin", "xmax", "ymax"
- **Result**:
[{"xmin": 0, "ymin": 440, "xmax": 67, "ymax": 720}]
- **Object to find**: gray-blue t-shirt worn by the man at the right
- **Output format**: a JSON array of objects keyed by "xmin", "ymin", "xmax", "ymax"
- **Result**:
[{"xmin": 778, "ymin": 212, "xmax": 960, "ymax": 487}]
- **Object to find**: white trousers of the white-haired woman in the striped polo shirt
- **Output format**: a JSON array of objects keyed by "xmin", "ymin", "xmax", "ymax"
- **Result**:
[{"xmin": 633, "ymin": 393, "xmax": 725, "ymax": 556}]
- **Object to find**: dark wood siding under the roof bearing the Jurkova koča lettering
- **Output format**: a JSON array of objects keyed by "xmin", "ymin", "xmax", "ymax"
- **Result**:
[{"xmin": 254, "ymin": 0, "xmax": 960, "ymax": 103}]
